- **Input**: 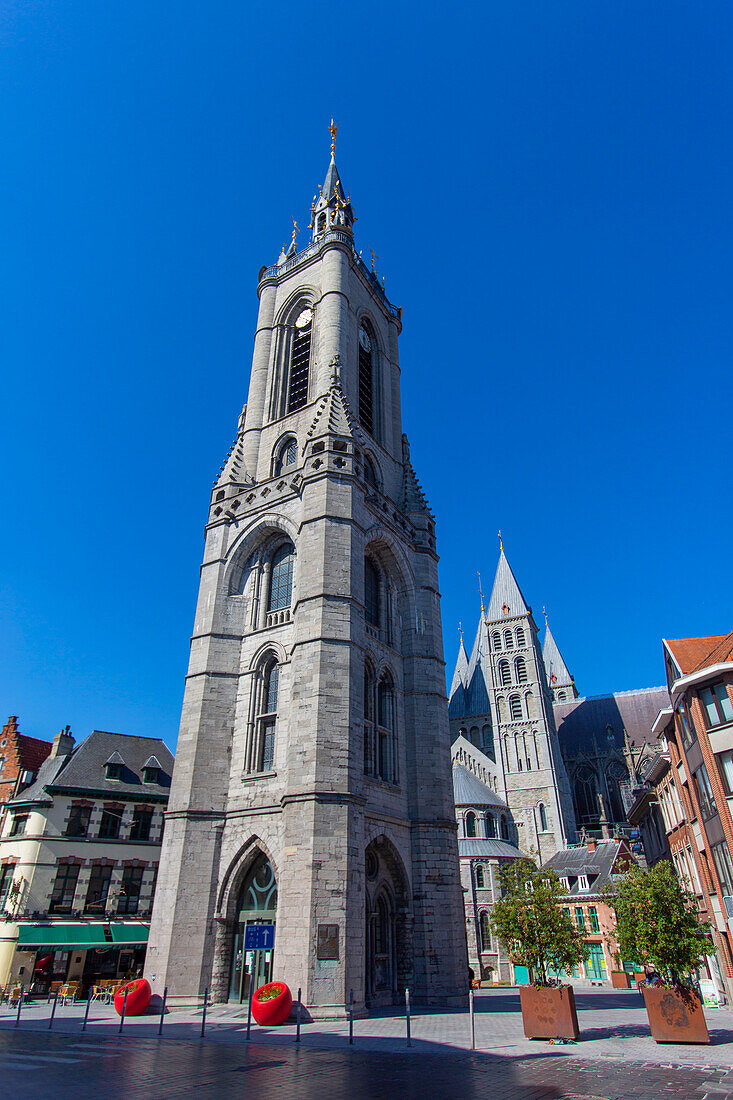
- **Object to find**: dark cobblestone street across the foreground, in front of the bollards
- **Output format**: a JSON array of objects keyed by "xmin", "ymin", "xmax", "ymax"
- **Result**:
[{"xmin": 0, "ymin": 1030, "xmax": 733, "ymax": 1100}]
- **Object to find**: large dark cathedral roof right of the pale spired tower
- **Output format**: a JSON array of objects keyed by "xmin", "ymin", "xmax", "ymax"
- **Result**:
[{"xmin": 553, "ymin": 688, "xmax": 669, "ymax": 757}]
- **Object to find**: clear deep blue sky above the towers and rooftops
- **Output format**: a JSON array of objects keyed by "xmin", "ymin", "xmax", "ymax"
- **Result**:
[{"xmin": 0, "ymin": 0, "xmax": 733, "ymax": 745}]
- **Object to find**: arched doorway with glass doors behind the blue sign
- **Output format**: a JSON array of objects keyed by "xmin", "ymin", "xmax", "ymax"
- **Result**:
[{"xmin": 229, "ymin": 854, "xmax": 277, "ymax": 1003}]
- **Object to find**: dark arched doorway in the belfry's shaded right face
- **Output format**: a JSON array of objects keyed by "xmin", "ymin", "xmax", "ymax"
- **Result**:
[{"xmin": 364, "ymin": 836, "xmax": 413, "ymax": 1008}]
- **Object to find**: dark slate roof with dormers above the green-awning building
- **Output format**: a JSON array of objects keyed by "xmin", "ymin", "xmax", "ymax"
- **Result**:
[{"xmin": 10, "ymin": 729, "xmax": 174, "ymax": 805}]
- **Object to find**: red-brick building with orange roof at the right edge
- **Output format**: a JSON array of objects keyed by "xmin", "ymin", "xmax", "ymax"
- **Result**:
[{"xmin": 654, "ymin": 634, "xmax": 733, "ymax": 1002}]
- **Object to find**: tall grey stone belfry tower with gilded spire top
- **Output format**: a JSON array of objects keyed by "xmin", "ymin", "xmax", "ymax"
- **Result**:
[{"xmin": 146, "ymin": 125, "xmax": 467, "ymax": 1016}]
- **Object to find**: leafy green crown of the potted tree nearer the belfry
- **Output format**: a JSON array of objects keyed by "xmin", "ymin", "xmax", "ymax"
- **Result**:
[{"xmin": 492, "ymin": 859, "xmax": 588, "ymax": 986}]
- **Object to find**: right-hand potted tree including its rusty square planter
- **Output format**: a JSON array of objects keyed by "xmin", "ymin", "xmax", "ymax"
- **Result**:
[{"xmin": 609, "ymin": 860, "xmax": 715, "ymax": 1043}]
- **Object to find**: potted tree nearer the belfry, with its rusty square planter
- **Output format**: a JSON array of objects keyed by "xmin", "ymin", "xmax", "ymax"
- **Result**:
[{"xmin": 493, "ymin": 859, "xmax": 588, "ymax": 1040}]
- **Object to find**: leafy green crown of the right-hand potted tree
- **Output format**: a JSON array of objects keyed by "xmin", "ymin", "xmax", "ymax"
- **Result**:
[{"xmin": 606, "ymin": 860, "xmax": 715, "ymax": 985}]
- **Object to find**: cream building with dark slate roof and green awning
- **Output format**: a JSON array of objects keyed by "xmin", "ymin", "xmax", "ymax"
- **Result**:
[{"xmin": 0, "ymin": 727, "xmax": 173, "ymax": 988}]
